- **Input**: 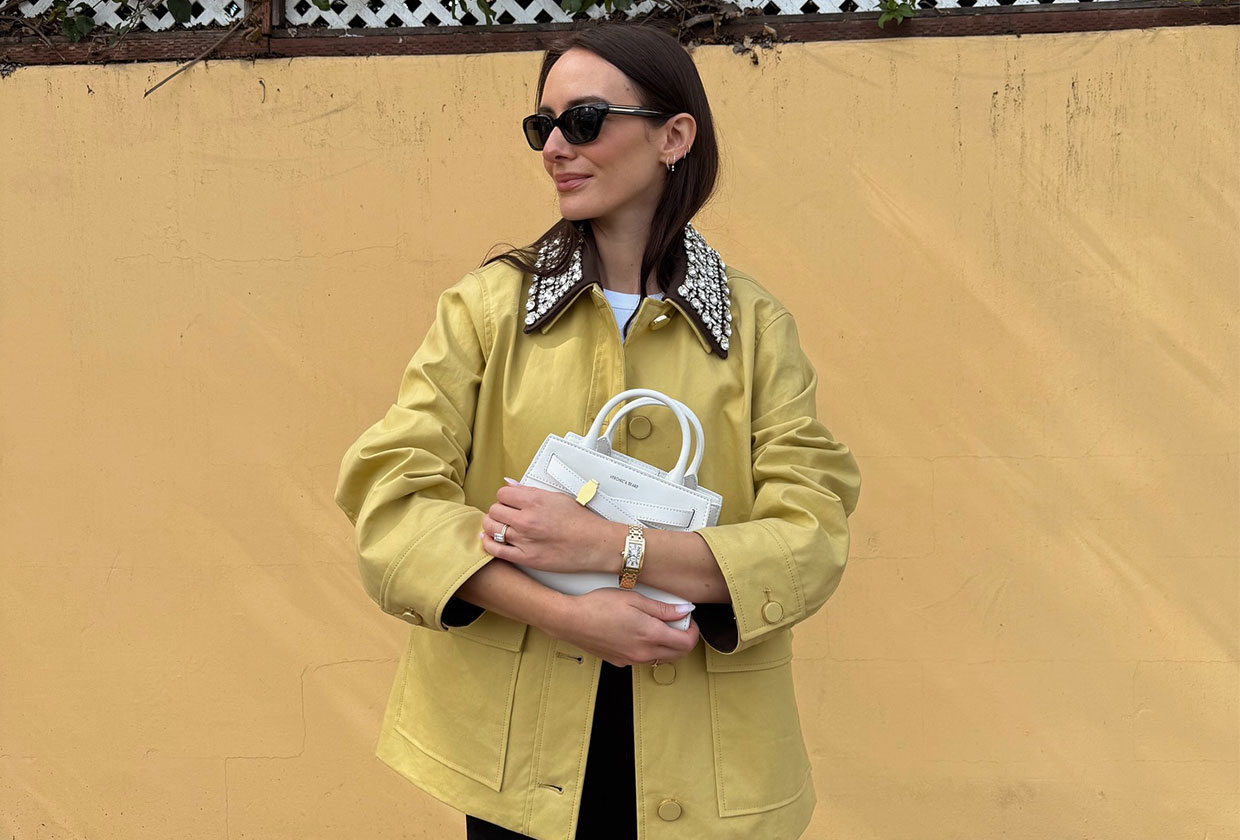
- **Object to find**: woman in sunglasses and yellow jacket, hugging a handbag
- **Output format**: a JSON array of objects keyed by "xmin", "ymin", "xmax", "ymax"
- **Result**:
[{"xmin": 337, "ymin": 25, "xmax": 858, "ymax": 840}]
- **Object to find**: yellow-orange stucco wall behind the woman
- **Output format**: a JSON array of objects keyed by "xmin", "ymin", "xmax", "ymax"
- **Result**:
[{"xmin": 0, "ymin": 27, "xmax": 1240, "ymax": 840}]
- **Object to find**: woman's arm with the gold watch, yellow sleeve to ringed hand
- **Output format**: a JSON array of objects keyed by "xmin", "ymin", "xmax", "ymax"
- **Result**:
[{"xmin": 482, "ymin": 310, "xmax": 859, "ymax": 653}]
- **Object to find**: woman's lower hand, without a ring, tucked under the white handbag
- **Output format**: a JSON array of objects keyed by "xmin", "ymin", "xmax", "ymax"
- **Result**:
[{"xmin": 543, "ymin": 589, "xmax": 698, "ymax": 665}]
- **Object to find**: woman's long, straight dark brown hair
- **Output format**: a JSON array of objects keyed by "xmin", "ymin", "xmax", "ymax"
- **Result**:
[{"xmin": 487, "ymin": 24, "xmax": 719, "ymax": 295}]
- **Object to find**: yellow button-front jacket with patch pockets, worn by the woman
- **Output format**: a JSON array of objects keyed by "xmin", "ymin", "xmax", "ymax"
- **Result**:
[{"xmin": 336, "ymin": 232, "xmax": 859, "ymax": 840}]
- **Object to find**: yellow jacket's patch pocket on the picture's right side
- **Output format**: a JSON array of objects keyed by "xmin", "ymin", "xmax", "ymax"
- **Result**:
[{"xmin": 706, "ymin": 632, "xmax": 810, "ymax": 816}]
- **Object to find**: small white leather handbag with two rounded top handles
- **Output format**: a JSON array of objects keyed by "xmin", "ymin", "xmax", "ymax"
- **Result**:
[{"xmin": 521, "ymin": 388, "xmax": 723, "ymax": 630}]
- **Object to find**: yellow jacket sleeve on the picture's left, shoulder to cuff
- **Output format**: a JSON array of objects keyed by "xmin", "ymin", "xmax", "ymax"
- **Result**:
[{"xmin": 336, "ymin": 274, "xmax": 490, "ymax": 630}]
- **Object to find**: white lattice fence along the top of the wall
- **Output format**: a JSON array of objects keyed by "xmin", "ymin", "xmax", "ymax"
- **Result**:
[{"xmin": 17, "ymin": 0, "xmax": 1135, "ymax": 31}]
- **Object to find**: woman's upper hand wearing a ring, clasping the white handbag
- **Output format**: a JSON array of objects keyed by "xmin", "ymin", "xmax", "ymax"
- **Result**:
[{"xmin": 482, "ymin": 484, "xmax": 627, "ymax": 574}]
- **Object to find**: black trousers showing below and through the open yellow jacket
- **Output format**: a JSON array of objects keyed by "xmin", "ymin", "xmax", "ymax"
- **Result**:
[{"xmin": 465, "ymin": 663, "xmax": 637, "ymax": 840}]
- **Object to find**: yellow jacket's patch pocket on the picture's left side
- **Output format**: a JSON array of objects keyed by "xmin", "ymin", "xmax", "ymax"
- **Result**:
[{"xmin": 396, "ymin": 613, "xmax": 526, "ymax": 790}]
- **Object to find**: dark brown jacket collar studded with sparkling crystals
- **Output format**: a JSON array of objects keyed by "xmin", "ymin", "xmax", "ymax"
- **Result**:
[{"xmin": 525, "ymin": 225, "xmax": 732, "ymax": 359}]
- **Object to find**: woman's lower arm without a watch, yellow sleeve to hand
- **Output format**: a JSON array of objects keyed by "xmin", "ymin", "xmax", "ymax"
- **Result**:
[{"xmin": 336, "ymin": 274, "xmax": 698, "ymax": 665}]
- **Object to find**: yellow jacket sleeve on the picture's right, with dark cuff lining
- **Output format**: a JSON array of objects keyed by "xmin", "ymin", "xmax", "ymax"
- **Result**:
[{"xmin": 694, "ymin": 310, "xmax": 861, "ymax": 653}]
